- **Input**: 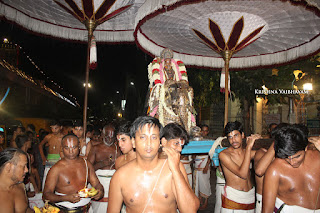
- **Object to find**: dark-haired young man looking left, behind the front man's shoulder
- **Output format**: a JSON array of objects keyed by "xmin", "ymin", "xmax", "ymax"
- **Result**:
[{"xmin": 115, "ymin": 122, "xmax": 136, "ymax": 169}]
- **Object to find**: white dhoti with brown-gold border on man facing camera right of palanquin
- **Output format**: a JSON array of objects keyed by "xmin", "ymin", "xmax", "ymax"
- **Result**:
[{"xmin": 221, "ymin": 186, "xmax": 255, "ymax": 213}]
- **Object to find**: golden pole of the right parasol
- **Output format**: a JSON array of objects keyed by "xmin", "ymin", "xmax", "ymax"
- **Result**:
[{"xmin": 222, "ymin": 50, "xmax": 232, "ymax": 127}]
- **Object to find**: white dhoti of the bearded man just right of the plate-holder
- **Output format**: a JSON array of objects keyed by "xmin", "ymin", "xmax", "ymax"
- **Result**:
[{"xmin": 91, "ymin": 169, "xmax": 116, "ymax": 213}]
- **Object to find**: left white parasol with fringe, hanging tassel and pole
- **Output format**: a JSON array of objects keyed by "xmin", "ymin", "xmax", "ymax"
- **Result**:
[{"xmin": 0, "ymin": 0, "xmax": 145, "ymax": 132}]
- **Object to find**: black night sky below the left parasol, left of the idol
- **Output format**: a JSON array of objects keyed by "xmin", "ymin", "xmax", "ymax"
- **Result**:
[{"xmin": 0, "ymin": 20, "xmax": 152, "ymax": 110}]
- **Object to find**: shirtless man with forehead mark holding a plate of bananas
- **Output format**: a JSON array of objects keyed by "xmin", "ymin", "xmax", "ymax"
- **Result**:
[{"xmin": 43, "ymin": 135, "xmax": 104, "ymax": 213}]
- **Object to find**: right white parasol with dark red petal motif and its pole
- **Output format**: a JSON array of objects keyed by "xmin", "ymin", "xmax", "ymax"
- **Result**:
[{"xmin": 134, "ymin": 0, "xmax": 320, "ymax": 124}]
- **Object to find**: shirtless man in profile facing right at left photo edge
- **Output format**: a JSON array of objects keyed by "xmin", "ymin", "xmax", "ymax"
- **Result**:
[{"xmin": 0, "ymin": 148, "xmax": 33, "ymax": 213}]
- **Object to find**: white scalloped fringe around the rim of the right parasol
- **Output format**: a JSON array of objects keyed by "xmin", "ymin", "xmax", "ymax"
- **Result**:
[{"xmin": 134, "ymin": 0, "xmax": 320, "ymax": 69}]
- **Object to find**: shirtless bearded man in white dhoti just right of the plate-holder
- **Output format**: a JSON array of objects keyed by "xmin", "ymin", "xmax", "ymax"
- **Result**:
[{"xmin": 88, "ymin": 125, "xmax": 120, "ymax": 212}]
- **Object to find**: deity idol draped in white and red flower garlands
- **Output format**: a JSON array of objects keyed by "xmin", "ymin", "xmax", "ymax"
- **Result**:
[{"xmin": 148, "ymin": 48, "xmax": 195, "ymax": 132}]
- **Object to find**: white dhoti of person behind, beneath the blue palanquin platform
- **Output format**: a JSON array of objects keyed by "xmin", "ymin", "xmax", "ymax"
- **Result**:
[{"xmin": 193, "ymin": 155, "xmax": 211, "ymax": 198}]
